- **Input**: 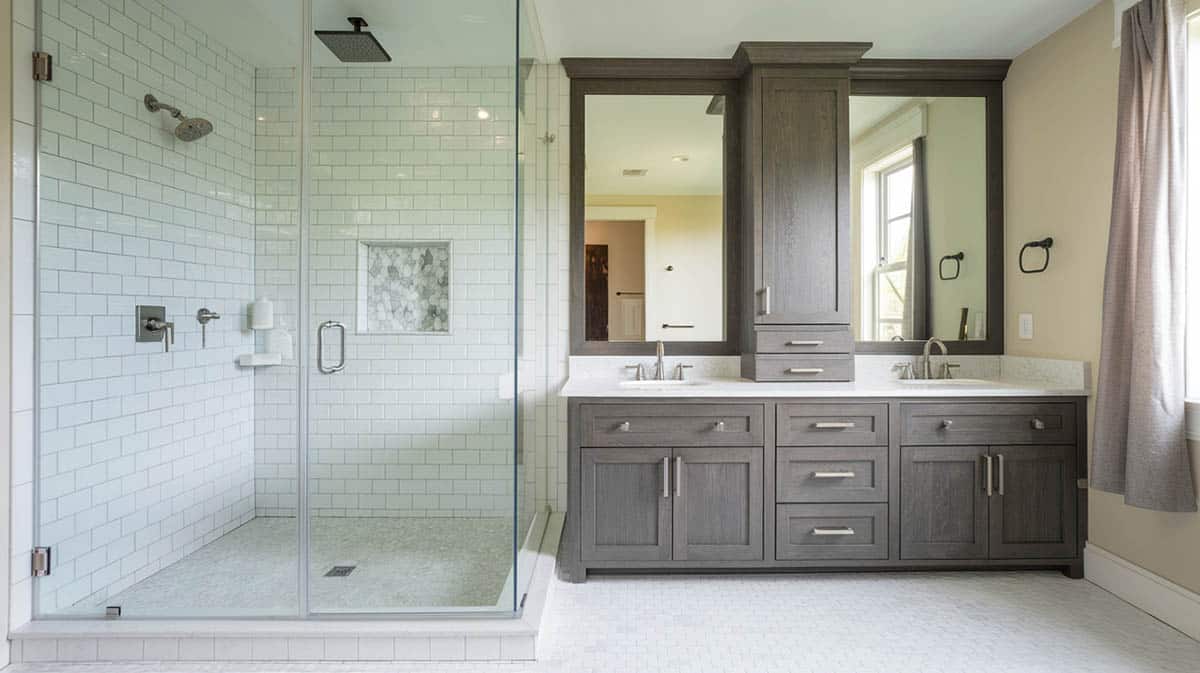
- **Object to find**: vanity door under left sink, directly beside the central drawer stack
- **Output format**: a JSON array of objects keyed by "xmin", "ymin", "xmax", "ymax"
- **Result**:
[{"xmin": 671, "ymin": 447, "xmax": 763, "ymax": 560}]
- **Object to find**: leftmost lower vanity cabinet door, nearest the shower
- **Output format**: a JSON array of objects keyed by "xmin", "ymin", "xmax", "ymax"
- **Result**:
[{"xmin": 580, "ymin": 449, "xmax": 672, "ymax": 560}]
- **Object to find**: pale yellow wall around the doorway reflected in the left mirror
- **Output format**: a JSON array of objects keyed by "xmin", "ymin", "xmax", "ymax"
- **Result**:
[{"xmin": 586, "ymin": 194, "xmax": 725, "ymax": 341}]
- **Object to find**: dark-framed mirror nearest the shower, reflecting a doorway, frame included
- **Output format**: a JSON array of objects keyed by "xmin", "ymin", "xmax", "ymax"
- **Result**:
[{"xmin": 571, "ymin": 79, "xmax": 739, "ymax": 355}]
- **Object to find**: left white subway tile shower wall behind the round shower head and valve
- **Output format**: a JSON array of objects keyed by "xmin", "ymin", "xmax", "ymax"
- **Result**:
[{"xmin": 34, "ymin": 0, "xmax": 254, "ymax": 612}]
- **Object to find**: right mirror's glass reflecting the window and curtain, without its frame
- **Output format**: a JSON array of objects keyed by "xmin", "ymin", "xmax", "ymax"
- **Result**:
[{"xmin": 850, "ymin": 96, "xmax": 988, "ymax": 341}]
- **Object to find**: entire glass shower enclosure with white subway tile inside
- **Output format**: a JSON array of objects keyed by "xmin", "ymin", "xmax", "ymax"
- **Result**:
[{"xmin": 35, "ymin": 0, "xmax": 547, "ymax": 618}]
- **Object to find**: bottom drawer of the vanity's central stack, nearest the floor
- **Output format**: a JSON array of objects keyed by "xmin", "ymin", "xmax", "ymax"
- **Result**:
[{"xmin": 775, "ymin": 503, "xmax": 888, "ymax": 560}]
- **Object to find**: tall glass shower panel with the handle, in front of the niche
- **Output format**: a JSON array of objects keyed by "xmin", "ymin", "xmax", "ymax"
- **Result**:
[{"xmin": 302, "ymin": 0, "xmax": 521, "ymax": 613}]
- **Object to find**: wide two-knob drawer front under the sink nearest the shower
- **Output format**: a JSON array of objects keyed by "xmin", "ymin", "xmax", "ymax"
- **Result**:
[{"xmin": 580, "ymin": 404, "xmax": 763, "ymax": 446}]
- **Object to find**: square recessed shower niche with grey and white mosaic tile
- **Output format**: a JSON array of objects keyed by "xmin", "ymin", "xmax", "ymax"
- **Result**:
[{"xmin": 358, "ymin": 241, "xmax": 450, "ymax": 334}]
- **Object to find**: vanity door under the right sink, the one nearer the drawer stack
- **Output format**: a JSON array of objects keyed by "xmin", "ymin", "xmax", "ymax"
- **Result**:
[{"xmin": 900, "ymin": 446, "xmax": 989, "ymax": 559}]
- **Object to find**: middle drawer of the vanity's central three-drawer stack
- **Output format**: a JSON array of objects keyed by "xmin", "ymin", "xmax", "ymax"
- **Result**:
[{"xmin": 775, "ymin": 446, "xmax": 888, "ymax": 503}]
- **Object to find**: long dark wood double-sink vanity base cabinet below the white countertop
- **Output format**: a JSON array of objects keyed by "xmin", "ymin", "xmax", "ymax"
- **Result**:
[{"xmin": 559, "ymin": 397, "xmax": 1087, "ymax": 582}]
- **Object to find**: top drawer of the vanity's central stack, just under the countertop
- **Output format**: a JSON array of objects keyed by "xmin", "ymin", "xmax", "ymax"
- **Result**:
[{"xmin": 775, "ymin": 403, "xmax": 888, "ymax": 446}]
